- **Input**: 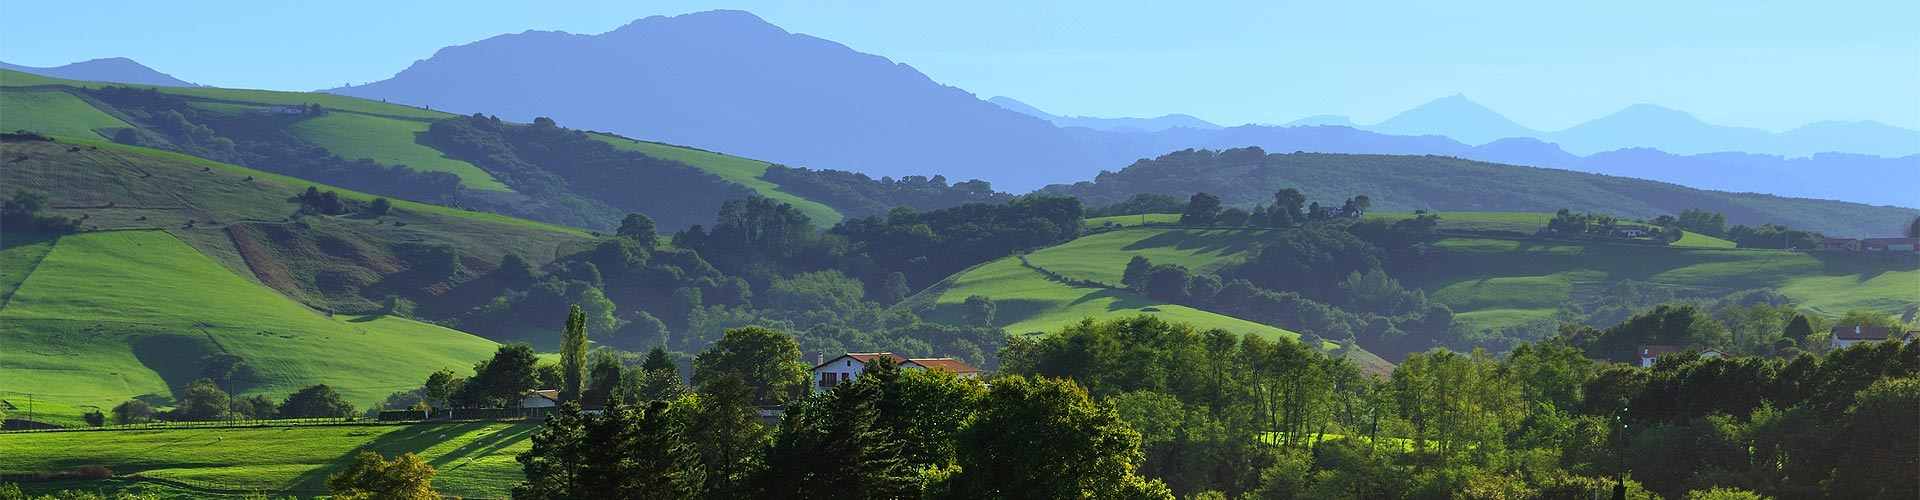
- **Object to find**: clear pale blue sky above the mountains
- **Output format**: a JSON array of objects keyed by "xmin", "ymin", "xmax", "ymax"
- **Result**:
[{"xmin": 0, "ymin": 0, "xmax": 1920, "ymax": 129}]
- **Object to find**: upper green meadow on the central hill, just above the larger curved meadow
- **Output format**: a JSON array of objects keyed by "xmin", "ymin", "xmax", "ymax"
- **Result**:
[{"xmin": 1027, "ymin": 229, "xmax": 1269, "ymax": 287}]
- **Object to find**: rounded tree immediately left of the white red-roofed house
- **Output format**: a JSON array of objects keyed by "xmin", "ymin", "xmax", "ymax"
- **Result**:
[{"xmin": 693, "ymin": 327, "xmax": 806, "ymax": 404}]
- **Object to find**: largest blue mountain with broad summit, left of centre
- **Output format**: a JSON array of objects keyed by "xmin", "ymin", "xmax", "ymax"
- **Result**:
[{"xmin": 328, "ymin": 12, "xmax": 1089, "ymax": 188}]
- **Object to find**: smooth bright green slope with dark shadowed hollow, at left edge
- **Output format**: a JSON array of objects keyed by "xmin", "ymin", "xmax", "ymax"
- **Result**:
[{"xmin": 0, "ymin": 231, "xmax": 493, "ymax": 421}]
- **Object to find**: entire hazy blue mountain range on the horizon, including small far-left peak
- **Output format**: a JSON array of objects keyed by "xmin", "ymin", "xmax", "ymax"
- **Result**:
[{"xmin": 15, "ymin": 12, "xmax": 1920, "ymax": 206}]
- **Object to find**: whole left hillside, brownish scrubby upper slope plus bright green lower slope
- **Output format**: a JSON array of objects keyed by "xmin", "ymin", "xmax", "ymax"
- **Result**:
[{"xmin": 0, "ymin": 138, "xmax": 610, "ymax": 423}]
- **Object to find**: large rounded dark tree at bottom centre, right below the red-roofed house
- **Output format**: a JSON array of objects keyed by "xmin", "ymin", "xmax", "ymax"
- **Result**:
[{"xmin": 947, "ymin": 375, "xmax": 1173, "ymax": 498}]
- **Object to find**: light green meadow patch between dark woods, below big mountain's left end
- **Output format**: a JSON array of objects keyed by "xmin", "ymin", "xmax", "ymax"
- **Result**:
[{"xmin": 290, "ymin": 113, "xmax": 511, "ymax": 190}]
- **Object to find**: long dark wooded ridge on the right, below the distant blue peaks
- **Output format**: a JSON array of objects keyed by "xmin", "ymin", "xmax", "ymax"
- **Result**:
[{"xmin": 1043, "ymin": 148, "xmax": 1920, "ymax": 237}]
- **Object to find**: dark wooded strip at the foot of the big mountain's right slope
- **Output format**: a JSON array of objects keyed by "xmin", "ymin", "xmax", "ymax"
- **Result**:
[{"xmin": 760, "ymin": 165, "xmax": 1014, "ymax": 217}]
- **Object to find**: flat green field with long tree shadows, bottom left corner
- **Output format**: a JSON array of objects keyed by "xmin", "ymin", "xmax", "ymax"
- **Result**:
[{"xmin": 0, "ymin": 423, "xmax": 536, "ymax": 498}]
